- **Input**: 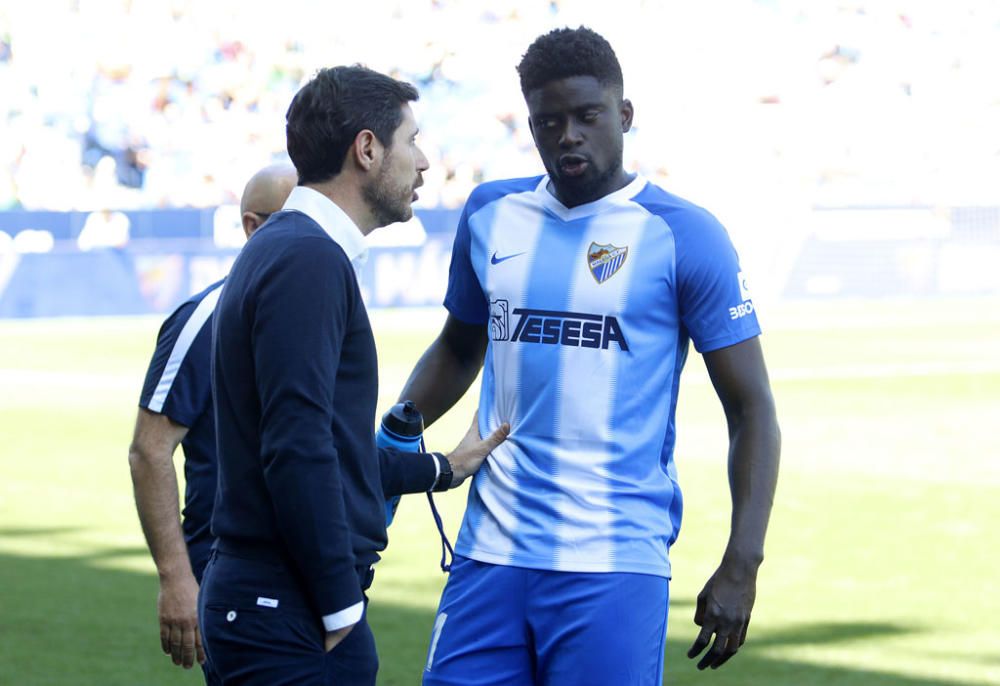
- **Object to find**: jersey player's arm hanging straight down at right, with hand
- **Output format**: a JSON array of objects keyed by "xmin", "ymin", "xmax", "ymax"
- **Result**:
[{"xmin": 688, "ymin": 337, "xmax": 781, "ymax": 669}]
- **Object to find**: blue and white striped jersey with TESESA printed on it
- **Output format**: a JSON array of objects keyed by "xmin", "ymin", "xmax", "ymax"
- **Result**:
[{"xmin": 445, "ymin": 177, "xmax": 760, "ymax": 577}]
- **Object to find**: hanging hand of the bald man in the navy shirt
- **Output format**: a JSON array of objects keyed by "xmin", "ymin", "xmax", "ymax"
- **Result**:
[{"xmin": 156, "ymin": 571, "xmax": 205, "ymax": 669}]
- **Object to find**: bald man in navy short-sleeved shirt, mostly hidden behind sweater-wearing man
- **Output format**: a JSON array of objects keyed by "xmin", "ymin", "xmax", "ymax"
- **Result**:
[{"xmin": 127, "ymin": 164, "xmax": 298, "ymax": 684}]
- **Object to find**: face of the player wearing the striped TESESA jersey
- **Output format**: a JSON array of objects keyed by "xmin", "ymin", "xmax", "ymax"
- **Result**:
[{"xmin": 526, "ymin": 76, "xmax": 633, "ymax": 207}]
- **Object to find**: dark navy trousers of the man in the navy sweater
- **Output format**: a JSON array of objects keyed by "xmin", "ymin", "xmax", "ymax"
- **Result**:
[{"xmin": 198, "ymin": 551, "xmax": 378, "ymax": 686}]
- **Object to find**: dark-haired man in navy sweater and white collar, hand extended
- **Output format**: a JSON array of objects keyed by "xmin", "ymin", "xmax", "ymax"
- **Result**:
[{"xmin": 199, "ymin": 67, "xmax": 509, "ymax": 686}]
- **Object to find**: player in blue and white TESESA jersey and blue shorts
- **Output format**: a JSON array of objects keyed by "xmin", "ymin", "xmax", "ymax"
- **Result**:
[{"xmin": 402, "ymin": 27, "xmax": 779, "ymax": 686}]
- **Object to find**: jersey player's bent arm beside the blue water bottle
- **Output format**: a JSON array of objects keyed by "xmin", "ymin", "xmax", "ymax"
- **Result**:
[{"xmin": 399, "ymin": 314, "xmax": 487, "ymax": 426}]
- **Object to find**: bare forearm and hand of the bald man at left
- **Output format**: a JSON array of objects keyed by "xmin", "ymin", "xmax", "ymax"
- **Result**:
[{"xmin": 128, "ymin": 408, "xmax": 205, "ymax": 668}]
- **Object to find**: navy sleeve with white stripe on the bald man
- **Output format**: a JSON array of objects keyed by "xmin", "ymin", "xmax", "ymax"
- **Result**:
[{"xmin": 139, "ymin": 296, "xmax": 221, "ymax": 428}]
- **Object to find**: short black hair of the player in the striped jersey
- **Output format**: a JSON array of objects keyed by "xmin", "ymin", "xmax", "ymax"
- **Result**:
[{"xmin": 517, "ymin": 26, "xmax": 624, "ymax": 97}]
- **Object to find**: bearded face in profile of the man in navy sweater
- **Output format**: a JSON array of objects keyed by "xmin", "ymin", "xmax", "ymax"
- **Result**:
[{"xmin": 364, "ymin": 105, "xmax": 430, "ymax": 226}]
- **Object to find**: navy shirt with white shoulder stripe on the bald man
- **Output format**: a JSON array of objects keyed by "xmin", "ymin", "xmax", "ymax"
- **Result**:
[{"xmin": 139, "ymin": 281, "xmax": 223, "ymax": 582}]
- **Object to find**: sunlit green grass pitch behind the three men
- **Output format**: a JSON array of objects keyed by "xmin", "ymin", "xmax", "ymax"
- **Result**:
[{"xmin": 0, "ymin": 299, "xmax": 1000, "ymax": 686}]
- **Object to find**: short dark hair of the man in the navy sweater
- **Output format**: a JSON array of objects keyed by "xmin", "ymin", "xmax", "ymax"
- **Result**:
[{"xmin": 285, "ymin": 65, "xmax": 420, "ymax": 185}]
